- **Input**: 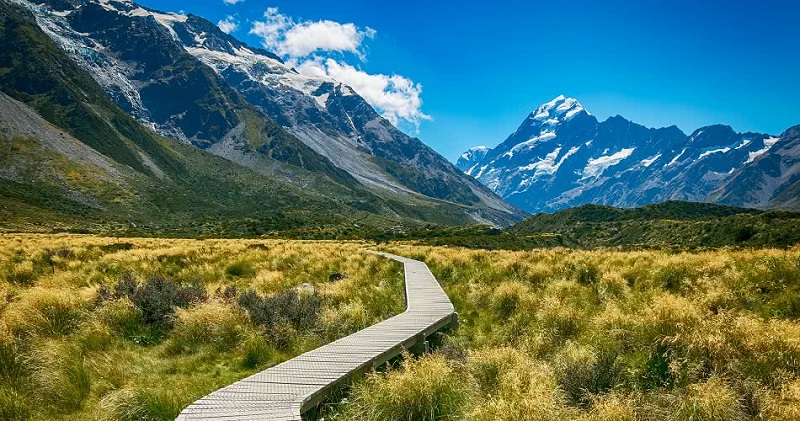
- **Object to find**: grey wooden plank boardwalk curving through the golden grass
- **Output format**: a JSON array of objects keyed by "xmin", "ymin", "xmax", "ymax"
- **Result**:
[{"xmin": 177, "ymin": 253, "xmax": 457, "ymax": 421}]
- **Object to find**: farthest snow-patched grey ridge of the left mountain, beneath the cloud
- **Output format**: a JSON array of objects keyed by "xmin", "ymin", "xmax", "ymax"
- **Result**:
[{"xmin": 170, "ymin": 12, "xmax": 516, "ymax": 214}]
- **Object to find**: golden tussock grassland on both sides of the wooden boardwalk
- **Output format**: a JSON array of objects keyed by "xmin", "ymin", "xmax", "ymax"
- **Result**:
[{"xmin": 0, "ymin": 234, "xmax": 800, "ymax": 421}]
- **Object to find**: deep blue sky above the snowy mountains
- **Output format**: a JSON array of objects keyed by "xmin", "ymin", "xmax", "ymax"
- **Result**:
[{"xmin": 139, "ymin": 0, "xmax": 800, "ymax": 160}]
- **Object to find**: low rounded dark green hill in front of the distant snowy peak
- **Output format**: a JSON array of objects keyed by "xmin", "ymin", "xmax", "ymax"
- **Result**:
[{"xmin": 511, "ymin": 202, "xmax": 800, "ymax": 248}]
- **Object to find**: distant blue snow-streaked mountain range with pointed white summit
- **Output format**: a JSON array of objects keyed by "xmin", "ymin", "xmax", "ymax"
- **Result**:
[{"xmin": 456, "ymin": 96, "xmax": 800, "ymax": 213}]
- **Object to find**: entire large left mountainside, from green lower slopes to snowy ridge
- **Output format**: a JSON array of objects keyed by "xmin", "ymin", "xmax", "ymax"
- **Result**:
[{"xmin": 0, "ymin": 0, "xmax": 525, "ymax": 234}]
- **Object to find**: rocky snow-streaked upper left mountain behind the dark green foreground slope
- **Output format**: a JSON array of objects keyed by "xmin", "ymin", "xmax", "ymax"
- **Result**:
[{"xmin": 7, "ymin": 0, "xmax": 524, "ymax": 225}]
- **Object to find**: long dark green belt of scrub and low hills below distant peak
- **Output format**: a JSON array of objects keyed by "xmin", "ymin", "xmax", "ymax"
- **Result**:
[{"xmin": 363, "ymin": 201, "xmax": 800, "ymax": 250}]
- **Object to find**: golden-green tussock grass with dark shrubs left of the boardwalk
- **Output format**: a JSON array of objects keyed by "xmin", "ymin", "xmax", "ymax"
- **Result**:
[{"xmin": 0, "ymin": 235, "xmax": 404, "ymax": 420}]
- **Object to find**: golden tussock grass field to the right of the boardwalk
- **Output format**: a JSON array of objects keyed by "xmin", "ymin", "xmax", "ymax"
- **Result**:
[{"xmin": 331, "ymin": 246, "xmax": 800, "ymax": 421}]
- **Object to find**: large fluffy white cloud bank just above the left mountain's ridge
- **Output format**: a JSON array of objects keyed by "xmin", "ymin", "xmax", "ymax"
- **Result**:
[{"xmin": 250, "ymin": 8, "xmax": 430, "ymax": 127}]
